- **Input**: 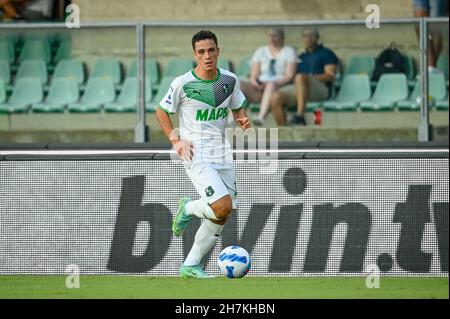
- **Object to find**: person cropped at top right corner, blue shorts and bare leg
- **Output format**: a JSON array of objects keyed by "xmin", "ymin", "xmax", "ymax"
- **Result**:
[{"xmin": 413, "ymin": 0, "xmax": 448, "ymax": 72}]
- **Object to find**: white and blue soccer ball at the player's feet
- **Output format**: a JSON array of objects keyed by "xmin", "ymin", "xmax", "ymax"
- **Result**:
[{"xmin": 217, "ymin": 246, "xmax": 251, "ymax": 278}]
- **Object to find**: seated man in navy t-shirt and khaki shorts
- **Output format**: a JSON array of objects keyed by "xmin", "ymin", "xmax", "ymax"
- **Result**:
[{"xmin": 270, "ymin": 29, "xmax": 338, "ymax": 125}]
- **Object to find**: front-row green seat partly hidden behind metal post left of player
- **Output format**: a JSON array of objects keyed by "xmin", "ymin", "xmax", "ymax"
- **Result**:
[{"xmin": 105, "ymin": 77, "xmax": 153, "ymax": 112}]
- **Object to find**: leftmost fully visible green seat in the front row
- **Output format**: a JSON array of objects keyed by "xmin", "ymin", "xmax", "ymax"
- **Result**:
[{"xmin": 0, "ymin": 78, "xmax": 44, "ymax": 113}]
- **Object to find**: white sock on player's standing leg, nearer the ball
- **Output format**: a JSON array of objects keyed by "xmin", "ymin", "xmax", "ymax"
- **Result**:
[{"xmin": 184, "ymin": 219, "xmax": 223, "ymax": 266}]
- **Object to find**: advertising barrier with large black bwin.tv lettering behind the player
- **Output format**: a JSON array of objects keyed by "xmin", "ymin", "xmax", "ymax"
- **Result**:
[{"xmin": 0, "ymin": 143, "xmax": 449, "ymax": 277}]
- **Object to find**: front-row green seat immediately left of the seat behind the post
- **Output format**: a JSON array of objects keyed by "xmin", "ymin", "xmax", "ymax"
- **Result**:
[{"xmin": 68, "ymin": 78, "xmax": 116, "ymax": 112}]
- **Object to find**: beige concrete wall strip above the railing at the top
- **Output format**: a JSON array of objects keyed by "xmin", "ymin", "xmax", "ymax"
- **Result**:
[{"xmin": 73, "ymin": 0, "xmax": 412, "ymax": 21}]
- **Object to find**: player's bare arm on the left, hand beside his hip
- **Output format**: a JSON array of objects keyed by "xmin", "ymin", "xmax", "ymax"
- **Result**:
[{"xmin": 156, "ymin": 107, "xmax": 192, "ymax": 160}]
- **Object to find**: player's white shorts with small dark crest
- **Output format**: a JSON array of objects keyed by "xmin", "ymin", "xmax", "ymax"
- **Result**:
[{"xmin": 184, "ymin": 162, "xmax": 237, "ymax": 209}]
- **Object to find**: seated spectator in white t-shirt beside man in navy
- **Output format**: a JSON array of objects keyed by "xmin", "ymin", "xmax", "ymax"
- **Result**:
[{"xmin": 240, "ymin": 29, "xmax": 297, "ymax": 125}]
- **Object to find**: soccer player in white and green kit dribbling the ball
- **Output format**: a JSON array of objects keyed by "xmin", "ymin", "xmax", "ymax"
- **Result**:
[{"xmin": 156, "ymin": 31, "xmax": 250, "ymax": 278}]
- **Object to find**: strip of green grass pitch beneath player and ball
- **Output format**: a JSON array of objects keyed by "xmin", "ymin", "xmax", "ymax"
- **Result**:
[{"xmin": 0, "ymin": 275, "xmax": 449, "ymax": 299}]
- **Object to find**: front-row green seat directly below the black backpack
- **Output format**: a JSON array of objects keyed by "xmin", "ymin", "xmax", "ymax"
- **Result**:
[{"xmin": 359, "ymin": 73, "xmax": 408, "ymax": 111}]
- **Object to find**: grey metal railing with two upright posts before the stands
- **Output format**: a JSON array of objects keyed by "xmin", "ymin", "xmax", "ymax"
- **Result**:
[{"xmin": 0, "ymin": 18, "xmax": 449, "ymax": 142}]
